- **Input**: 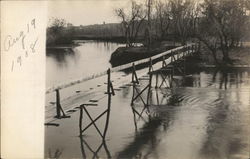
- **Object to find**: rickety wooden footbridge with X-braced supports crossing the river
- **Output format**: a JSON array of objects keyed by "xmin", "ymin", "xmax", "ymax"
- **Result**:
[{"xmin": 45, "ymin": 43, "xmax": 199, "ymax": 135}]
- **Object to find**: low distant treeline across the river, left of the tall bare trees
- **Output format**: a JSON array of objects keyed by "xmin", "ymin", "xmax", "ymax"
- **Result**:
[{"xmin": 46, "ymin": 18, "xmax": 124, "ymax": 46}]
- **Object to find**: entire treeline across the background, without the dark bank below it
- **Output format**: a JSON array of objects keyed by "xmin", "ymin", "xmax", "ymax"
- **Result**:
[{"xmin": 47, "ymin": 0, "xmax": 250, "ymax": 62}]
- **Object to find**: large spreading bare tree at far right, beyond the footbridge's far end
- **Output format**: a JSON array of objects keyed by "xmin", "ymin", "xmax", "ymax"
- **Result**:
[{"xmin": 198, "ymin": 0, "xmax": 247, "ymax": 63}]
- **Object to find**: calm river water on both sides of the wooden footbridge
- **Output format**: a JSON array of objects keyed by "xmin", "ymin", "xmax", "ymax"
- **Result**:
[{"xmin": 45, "ymin": 42, "xmax": 250, "ymax": 159}]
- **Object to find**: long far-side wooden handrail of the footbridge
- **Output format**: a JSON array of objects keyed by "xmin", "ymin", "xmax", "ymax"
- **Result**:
[{"xmin": 46, "ymin": 43, "xmax": 195, "ymax": 94}]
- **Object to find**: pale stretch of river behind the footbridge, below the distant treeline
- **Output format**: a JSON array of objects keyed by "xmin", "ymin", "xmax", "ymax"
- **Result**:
[{"xmin": 46, "ymin": 40, "xmax": 124, "ymax": 87}]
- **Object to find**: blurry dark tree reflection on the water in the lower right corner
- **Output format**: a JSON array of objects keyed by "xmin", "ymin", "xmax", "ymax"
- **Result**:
[{"xmin": 201, "ymin": 94, "xmax": 248, "ymax": 158}]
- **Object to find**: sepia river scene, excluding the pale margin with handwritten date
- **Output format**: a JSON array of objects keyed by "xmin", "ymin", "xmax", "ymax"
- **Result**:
[{"xmin": 44, "ymin": 0, "xmax": 250, "ymax": 159}]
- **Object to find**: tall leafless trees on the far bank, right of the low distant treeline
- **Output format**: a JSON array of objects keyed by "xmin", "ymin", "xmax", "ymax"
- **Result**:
[{"xmin": 115, "ymin": 0, "xmax": 250, "ymax": 62}]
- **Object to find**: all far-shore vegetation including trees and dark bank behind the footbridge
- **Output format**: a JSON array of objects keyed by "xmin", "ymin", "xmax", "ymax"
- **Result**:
[{"xmin": 46, "ymin": 0, "xmax": 250, "ymax": 67}]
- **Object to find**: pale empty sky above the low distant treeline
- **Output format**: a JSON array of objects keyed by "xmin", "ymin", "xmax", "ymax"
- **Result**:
[{"xmin": 48, "ymin": 0, "xmax": 133, "ymax": 25}]
